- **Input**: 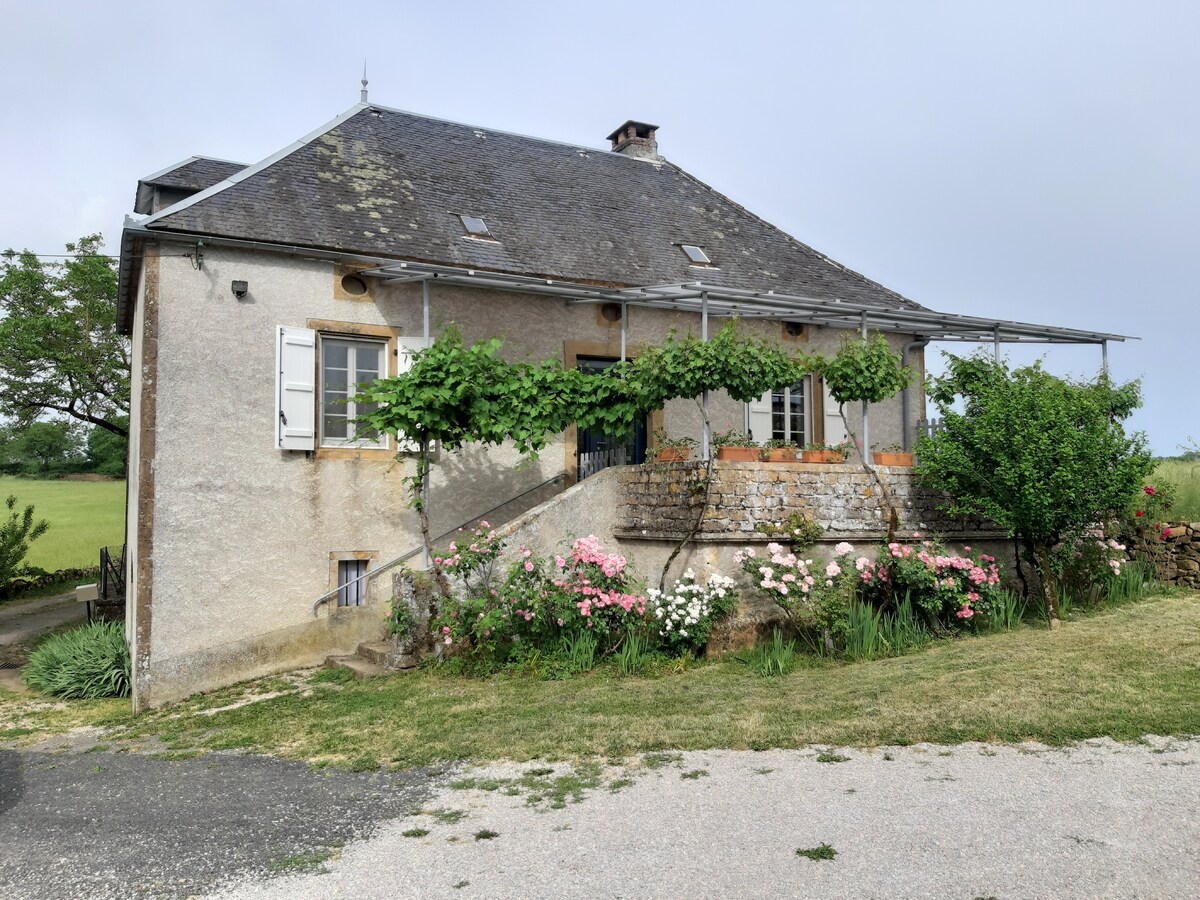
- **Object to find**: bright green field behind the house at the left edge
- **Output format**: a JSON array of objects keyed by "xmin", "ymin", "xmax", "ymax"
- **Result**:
[{"xmin": 0, "ymin": 478, "xmax": 125, "ymax": 571}]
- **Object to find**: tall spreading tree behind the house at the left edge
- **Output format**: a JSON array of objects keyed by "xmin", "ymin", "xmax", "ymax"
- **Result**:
[{"xmin": 0, "ymin": 234, "xmax": 130, "ymax": 434}]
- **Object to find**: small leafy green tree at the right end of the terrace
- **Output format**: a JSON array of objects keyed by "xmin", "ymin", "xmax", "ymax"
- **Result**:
[{"xmin": 917, "ymin": 354, "xmax": 1154, "ymax": 628}]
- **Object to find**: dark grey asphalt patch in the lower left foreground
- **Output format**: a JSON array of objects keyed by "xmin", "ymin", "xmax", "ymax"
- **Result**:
[{"xmin": 0, "ymin": 750, "xmax": 446, "ymax": 900}]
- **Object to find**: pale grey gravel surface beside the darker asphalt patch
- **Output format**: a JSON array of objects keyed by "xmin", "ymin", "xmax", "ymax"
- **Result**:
[{"xmin": 211, "ymin": 739, "xmax": 1200, "ymax": 900}]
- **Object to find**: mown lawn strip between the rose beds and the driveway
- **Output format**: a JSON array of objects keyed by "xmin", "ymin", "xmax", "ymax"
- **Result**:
[{"xmin": 0, "ymin": 594, "xmax": 1200, "ymax": 769}]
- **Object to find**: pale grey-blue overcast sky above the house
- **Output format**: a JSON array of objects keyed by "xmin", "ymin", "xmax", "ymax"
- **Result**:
[{"xmin": 0, "ymin": 0, "xmax": 1200, "ymax": 454}]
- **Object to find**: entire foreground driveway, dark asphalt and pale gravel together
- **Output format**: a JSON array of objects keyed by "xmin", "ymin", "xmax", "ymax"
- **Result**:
[{"xmin": 0, "ymin": 738, "xmax": 1200, "ymax": 900}]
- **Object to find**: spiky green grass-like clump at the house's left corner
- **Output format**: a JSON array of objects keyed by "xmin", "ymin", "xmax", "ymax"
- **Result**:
[{"xmin": 22, "ymin": 622, "xmax": 130, "ymax": 700}]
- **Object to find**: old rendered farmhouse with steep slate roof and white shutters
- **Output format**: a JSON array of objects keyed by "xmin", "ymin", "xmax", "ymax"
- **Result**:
[{"xmin": 119, "ymin": 91, "xmax": 1120, "ymax": 709}]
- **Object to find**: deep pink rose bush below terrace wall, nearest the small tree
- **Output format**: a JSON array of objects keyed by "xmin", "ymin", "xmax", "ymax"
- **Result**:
[{"xmin": 854, "ymin": 534, "xmax": 1001, "ymax": 625}]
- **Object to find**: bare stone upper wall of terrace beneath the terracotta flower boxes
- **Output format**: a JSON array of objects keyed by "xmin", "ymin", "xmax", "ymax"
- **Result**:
[{"xmin": 613, "ymin": 462, "xmax": 1003, "ymax": 542}]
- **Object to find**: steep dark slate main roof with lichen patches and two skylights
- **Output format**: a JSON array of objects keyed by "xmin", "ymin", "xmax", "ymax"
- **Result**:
[{"xmin": 146, "ymin": 106, "xmax": 923, "ymax": 310}]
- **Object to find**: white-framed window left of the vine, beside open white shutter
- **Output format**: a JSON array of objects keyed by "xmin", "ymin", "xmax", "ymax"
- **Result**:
[{"xmin": 320, "ymin": 335, "xmax": 388, "ymax": 449}]
